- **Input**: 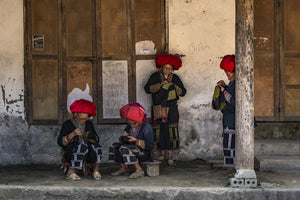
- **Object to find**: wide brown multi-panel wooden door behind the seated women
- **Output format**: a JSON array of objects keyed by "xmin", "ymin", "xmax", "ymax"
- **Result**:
[{"xmin": 24, "ymin": 0, "xmax": 166, "ymax": 124}]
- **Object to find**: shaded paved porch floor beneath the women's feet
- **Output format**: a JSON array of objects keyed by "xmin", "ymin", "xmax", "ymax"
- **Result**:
[{"xmin": 0, "ymin": 160, "xmax": 300, "ymax": 188}]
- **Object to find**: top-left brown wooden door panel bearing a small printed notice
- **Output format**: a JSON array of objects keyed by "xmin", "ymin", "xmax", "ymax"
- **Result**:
[{"xmin": 31, "ymin": 0, "xmax": 57, "ymax": 55}]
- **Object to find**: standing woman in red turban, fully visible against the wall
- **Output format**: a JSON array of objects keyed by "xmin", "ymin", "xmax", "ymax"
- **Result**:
[{"xmin": 144, "ymin": 54, "xmax": 186, "ymax": 165}]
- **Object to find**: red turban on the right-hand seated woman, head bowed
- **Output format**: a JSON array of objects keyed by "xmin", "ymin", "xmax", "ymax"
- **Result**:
[{"xmin": 120, "ymin": 103, "xmax": 147, "ymax": 124}]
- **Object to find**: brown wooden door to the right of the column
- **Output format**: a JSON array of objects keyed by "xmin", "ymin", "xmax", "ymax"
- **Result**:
[{"xmin": 254, "ymin": 0, "xmax": 300, "ymax": 121}]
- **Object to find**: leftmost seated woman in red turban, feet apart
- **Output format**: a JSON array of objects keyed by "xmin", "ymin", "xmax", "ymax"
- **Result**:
[{"xmin": 57, "ymin": 99, "xmax": 102, "ymax": 181}]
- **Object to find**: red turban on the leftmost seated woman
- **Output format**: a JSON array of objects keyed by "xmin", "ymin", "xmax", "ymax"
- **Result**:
[{"xmin": 70, "ymin": 99, "xmax": 96, "ymax": 116}]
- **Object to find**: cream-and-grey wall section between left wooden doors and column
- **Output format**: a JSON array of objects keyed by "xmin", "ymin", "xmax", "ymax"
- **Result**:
[{"xmin": 169, "ymin": 0, "xmax": 235, "ymax": 159}]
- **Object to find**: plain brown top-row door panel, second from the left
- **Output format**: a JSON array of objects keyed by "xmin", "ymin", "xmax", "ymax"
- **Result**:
[{"xmin": 66, "ymin": 0, "xmax": 92, "ymax": 56}]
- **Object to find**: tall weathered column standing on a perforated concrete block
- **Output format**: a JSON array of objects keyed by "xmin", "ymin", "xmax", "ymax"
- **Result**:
[{"xmin": 230, "ymin": 0, "xmax": 257, "ymax": 187}]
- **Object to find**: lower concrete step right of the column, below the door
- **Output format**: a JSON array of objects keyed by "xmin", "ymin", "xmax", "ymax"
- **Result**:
[{"xmin": 255, "ymin": 156, "xmax": 300, "ymax": 173}]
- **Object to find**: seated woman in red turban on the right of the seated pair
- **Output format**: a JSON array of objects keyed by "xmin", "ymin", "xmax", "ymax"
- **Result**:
[{"xmin": 109, "ymin": 103, "xmax": 154, "ymax": 179}]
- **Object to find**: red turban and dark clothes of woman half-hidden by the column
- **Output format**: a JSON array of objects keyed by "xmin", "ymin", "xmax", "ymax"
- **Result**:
[{"xmin": 212, "ymin": 55, "xmax": 236, "ymax": 167}]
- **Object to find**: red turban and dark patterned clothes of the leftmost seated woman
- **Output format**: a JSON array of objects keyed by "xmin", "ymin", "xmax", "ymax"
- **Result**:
[{"xmin": 57, "ymin": 99, "xmax": 102, "ymax": 173}]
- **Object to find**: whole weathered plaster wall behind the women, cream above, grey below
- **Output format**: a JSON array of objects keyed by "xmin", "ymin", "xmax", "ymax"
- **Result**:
[{"xmin": 0, "ymin": 0, "xmax": 235, "ymax": 165}]
